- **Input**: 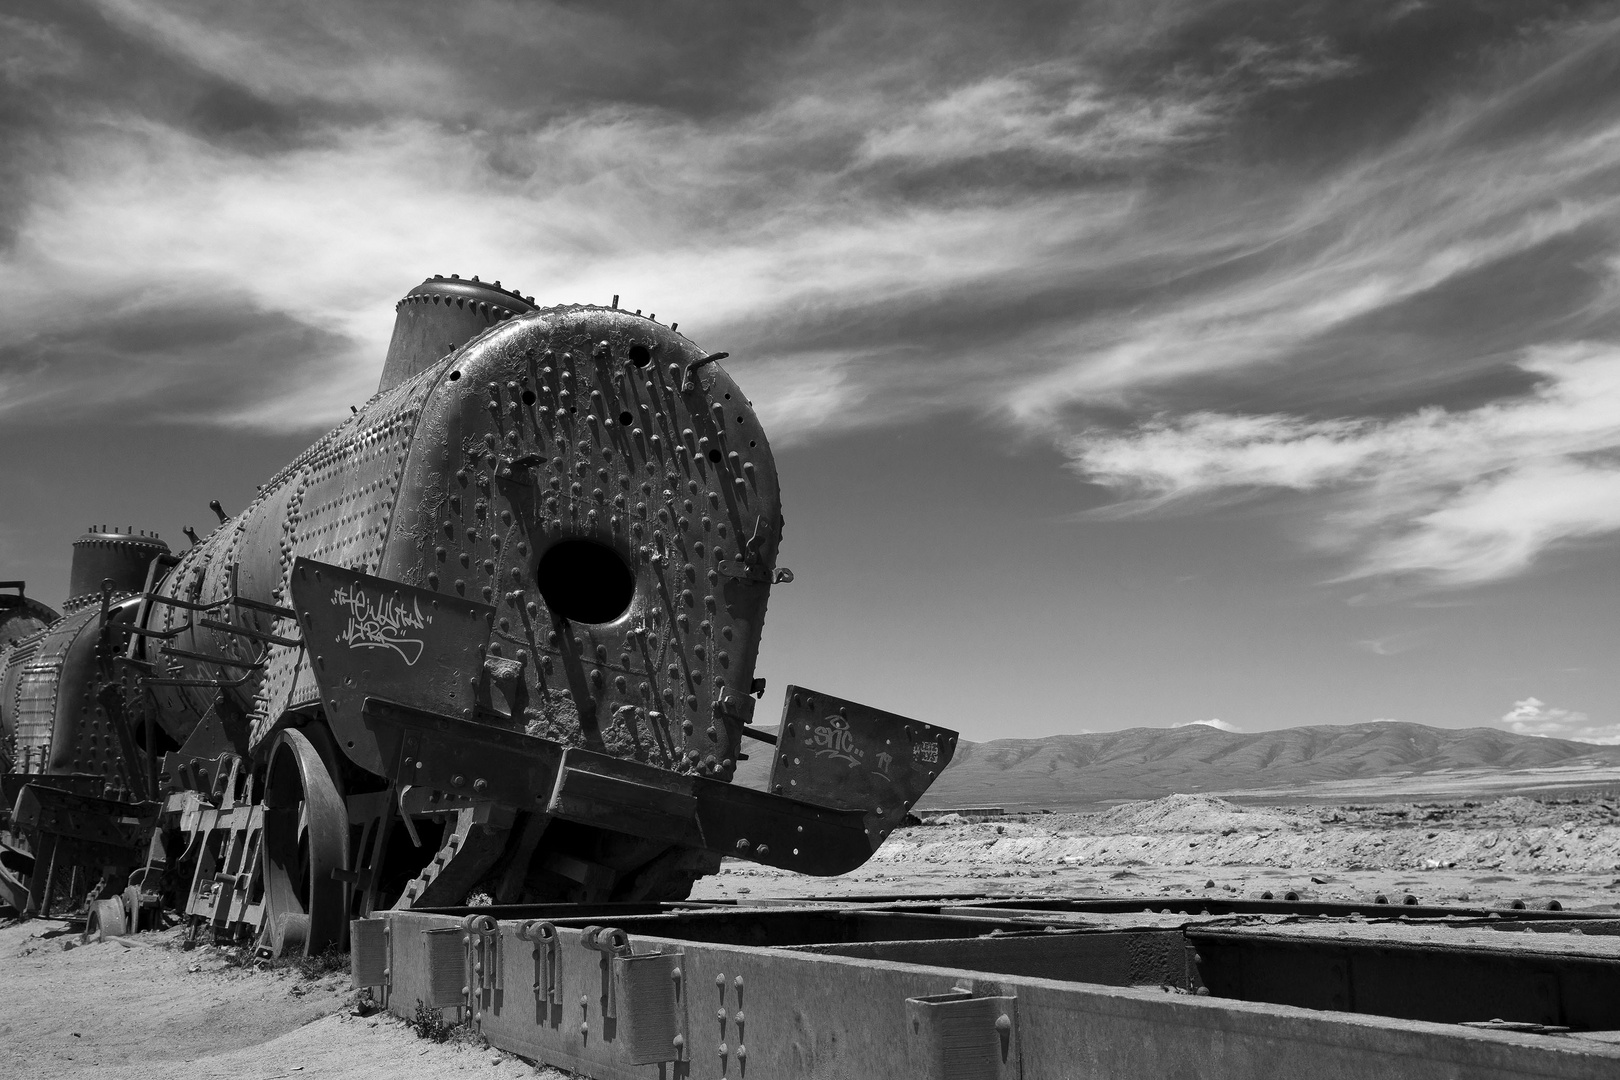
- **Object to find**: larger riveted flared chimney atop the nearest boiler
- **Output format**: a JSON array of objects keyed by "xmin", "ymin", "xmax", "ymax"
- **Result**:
[{"xmin": 377, "ymin": 274, "xmax": 535, "ymax": 393}]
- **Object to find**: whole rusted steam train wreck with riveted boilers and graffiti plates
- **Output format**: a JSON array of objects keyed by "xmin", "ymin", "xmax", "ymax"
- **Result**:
[{"xmin": 0, "ymin": 277, "xmax": 954, "ymax": 950}]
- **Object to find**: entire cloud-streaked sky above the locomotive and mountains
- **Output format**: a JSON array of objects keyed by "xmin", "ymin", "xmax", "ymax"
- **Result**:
[{"xmin": 0, "ymin": 0, "xmax": 1620, "ymax": 743}]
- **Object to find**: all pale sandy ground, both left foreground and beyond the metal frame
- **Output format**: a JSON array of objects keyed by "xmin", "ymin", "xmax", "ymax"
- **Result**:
[{"xmin": 0, "ymin": 795, "xmax": 1620, "ymax": 1080}]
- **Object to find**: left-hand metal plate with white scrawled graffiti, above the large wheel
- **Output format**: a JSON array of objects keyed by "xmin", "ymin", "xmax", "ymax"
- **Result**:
[{"xmin": 290, "ymin": 559, "xmax": 496, "ymax": 772}]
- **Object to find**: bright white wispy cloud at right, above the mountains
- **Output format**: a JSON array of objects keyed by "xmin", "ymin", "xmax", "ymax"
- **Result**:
[{"xmin": 1072, "ymin": 345, "xmax": 1620, "ymax": 585}]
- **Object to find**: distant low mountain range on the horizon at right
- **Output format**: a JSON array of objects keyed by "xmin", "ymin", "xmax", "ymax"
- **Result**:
[{"xmin": 737, "ymin": 722, "xmax": 1620, "ymax": 810}]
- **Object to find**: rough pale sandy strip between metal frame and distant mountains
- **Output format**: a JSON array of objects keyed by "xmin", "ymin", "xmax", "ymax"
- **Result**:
[{"xmin": 693, "ymin": 795, "xmax": 1620, "ymax": 910}]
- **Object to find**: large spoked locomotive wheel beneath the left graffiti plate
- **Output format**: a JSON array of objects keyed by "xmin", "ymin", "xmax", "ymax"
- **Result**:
[{"xmin": 261, "ymin": 729, "xmax": 348, "ymax": 955}]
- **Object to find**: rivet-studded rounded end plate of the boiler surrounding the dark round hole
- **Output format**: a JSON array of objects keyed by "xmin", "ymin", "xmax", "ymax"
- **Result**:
[{"xmin": 411, "ymin": 306, "xmax": 779, "ymax": 774}]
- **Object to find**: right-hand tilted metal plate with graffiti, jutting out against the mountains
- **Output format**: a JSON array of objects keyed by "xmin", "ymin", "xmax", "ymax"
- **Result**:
[{"xmin": 770, "ymin": 687, "xmax": 956, "ymax": 847}]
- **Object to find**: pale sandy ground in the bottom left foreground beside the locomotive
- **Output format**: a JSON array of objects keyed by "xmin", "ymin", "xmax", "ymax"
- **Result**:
[{"xmin": 0, "ymin": 920, "xmax": 565, "ymax": 1080}]
